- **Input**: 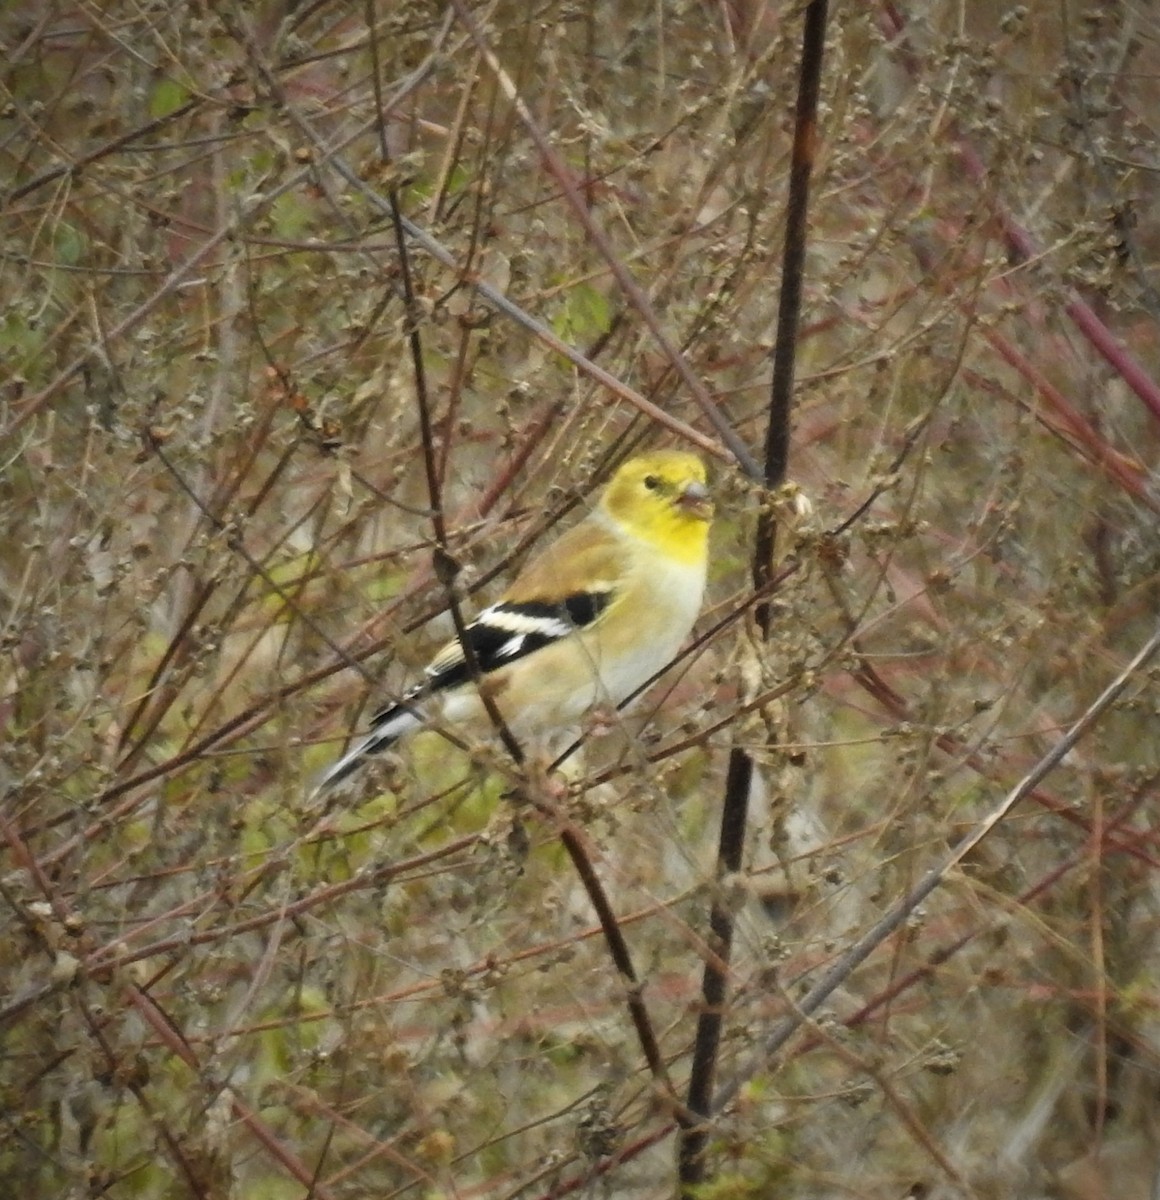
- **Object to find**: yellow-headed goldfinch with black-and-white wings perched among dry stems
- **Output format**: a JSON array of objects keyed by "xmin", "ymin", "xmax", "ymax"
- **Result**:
[{"xmin": 318, "ymin": 450, "xmax": 713, "ymax": 790}]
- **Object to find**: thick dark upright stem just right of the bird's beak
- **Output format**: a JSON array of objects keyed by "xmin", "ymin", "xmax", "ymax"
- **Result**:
[{"xmin": 679, "ymin": 0, "xmax": 827, "ymax": 1195}]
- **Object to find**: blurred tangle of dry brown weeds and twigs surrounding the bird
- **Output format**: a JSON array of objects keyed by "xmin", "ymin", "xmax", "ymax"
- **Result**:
[{"xmin": 0, "ymin": 0, "xmax": 1160, "ymax": 1200}]
